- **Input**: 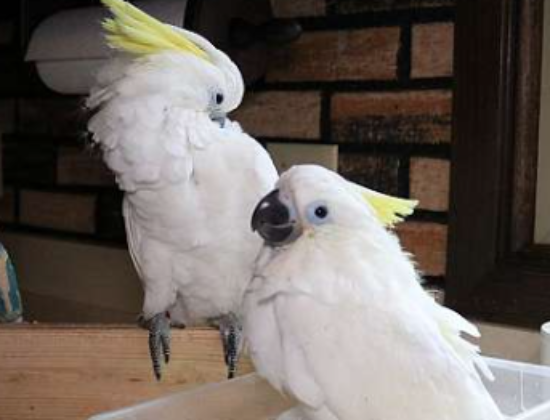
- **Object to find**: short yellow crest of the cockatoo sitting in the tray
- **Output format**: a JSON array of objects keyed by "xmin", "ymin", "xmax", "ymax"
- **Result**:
[{"xmin": 350, "ymin": 182, "xmax": 418, "ymax": 227}]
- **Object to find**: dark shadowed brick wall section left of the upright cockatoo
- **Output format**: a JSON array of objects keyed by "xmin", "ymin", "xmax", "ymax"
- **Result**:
[{"xmin": 0, "ymin": 0, "xmax": 125, "ymax": 246}]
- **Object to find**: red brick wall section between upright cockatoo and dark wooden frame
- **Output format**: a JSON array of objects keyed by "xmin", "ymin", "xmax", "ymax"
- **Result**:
[{"xmin": 235, "ymin": 0, "xmax": 454, "ymax": 284}]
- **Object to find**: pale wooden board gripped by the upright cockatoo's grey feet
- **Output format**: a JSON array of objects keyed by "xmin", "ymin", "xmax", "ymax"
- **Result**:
[{"xmin": 0, "ymin": 324, "xmax": 252, "ymax": 420}]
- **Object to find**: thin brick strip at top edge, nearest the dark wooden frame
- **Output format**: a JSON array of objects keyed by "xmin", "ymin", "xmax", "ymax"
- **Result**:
[{"xmin": 334, "ymin": 0, "xmax": 455, "ymax": 14}]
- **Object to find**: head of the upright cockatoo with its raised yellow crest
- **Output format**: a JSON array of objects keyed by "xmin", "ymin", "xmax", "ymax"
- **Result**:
[{"xmin": 88, "ymin": 0, "xmax": 244, "ymax": 114}]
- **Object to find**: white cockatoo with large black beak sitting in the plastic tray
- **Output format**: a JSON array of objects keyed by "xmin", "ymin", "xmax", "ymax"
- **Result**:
[{"xmin": 244, "ymin": 166, "xmax": 502, "ymax": 420}]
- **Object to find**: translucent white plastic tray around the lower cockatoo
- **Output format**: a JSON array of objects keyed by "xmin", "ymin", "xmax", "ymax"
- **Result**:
[{"xmin": 90, "ymin": 358, "xmax": 550, "ymax": 420}]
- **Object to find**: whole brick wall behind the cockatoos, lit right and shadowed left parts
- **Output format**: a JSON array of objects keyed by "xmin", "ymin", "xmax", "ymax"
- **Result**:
[{"xmin": 0, "ymin": 0, "xmax": 453, "ymax": 282}]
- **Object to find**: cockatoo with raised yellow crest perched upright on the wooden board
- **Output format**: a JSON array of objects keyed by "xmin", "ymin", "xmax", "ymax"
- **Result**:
[{"xmin": 87, "ymin": 0, "xmax": 277, "ymax": 378}]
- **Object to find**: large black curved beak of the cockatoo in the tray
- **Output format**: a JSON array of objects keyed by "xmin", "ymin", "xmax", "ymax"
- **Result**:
[{"xmin": 251, "ymin": 190, "xmax": 299, "ymax": 246}]
